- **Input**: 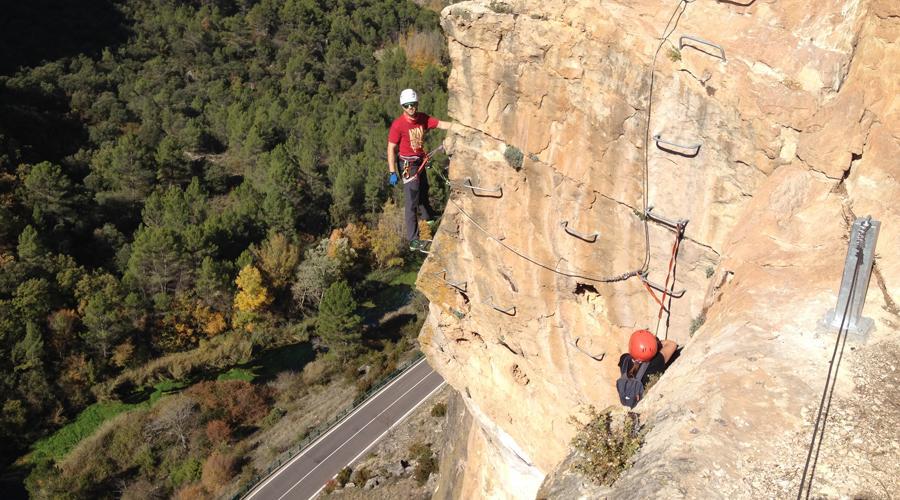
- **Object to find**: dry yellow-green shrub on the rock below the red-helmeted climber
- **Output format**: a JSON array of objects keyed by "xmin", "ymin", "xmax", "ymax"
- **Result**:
[{"xmin": 572, "ymin": 407, "xmax": 647, "ymax": 486}]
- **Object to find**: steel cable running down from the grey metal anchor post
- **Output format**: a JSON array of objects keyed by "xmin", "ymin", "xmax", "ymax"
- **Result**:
[{"xmin": 797, "ymin": 225, "xmax": 868, "ymax": 500}]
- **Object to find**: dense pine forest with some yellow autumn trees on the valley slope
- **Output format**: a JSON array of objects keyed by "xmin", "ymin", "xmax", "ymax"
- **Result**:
[{"xmin": 0, "ymin": 0, "xmax": 449, "ymax": 498}]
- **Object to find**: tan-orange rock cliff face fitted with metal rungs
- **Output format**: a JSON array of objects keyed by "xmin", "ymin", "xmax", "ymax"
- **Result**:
[{"xmin": 418, "ymin": 0, "xmax": 900, "ymax": 498}]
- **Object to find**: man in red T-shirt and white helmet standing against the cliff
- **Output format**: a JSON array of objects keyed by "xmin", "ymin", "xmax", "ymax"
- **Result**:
[{"xmin": 387, "ymin": 89, "xmax": 450, "ymax": 250}]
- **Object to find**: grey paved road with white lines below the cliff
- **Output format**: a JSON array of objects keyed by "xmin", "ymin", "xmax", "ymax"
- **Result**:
[{"xmin": 245, "ymin": 358, "xmax": 444, "ymax": 500}]
